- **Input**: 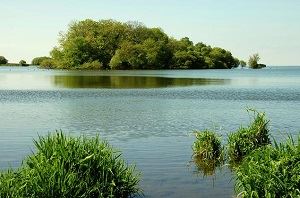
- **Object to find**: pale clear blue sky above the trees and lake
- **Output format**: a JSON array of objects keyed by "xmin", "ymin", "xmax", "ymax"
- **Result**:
[{"xmin": 0, "ymin": 0, "xmax": 300, "ymax": 66}]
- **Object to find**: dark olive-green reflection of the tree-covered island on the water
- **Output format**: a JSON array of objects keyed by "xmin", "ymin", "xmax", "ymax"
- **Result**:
[{"xmin": 52, "ymin": 76, "xmax": 230, "ymax": 89}]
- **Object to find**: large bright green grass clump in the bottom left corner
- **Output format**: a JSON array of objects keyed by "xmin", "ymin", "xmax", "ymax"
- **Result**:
[{"xmin": 0, "ymin": 132, "xmax": 140, "ymax": 198}]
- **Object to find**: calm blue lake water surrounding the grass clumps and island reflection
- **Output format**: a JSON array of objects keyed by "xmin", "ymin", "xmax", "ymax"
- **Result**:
[{"xmin": 0, "ymin": 67, "xmax": 300, "ymax": 198}]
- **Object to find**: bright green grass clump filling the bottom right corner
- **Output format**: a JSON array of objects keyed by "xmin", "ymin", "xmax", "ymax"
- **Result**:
[{"xmin": 236, "ymin": 135, "xmax": 300, "ymax": 198}]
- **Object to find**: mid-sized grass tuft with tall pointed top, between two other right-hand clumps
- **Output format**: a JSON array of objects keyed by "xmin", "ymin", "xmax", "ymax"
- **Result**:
[{"xmin": 228, "ymin": 110, "xmax": 271, "ymax": 163}]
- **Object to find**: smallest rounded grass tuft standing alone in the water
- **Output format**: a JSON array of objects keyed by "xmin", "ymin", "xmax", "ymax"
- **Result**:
[{"xmin": 193, "ymin": 130, "xmax": 223, "ymax": 176}]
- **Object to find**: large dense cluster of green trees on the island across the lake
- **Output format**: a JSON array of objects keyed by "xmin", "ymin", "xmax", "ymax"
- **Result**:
[{"xmin": 42, "ymin": 19, "xmax": 239, "ymax": 69}]
